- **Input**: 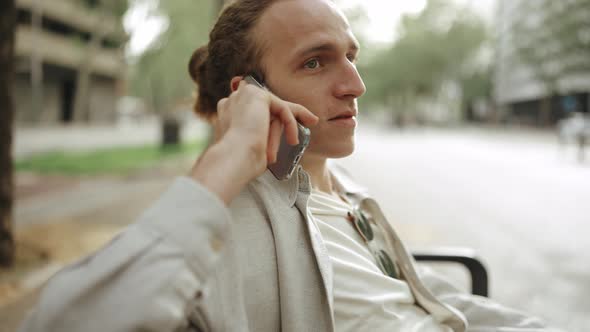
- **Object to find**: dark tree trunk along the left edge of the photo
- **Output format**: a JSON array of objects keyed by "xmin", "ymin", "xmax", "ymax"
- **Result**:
[{"xmin": 0, "ymin": 0, "xmax": 16, "ymax": 266}]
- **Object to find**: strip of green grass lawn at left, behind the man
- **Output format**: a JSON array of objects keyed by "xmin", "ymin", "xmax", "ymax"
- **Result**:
[{"xmin": 15, "ymin": 142, "xmax": 204, "ymax": 175}]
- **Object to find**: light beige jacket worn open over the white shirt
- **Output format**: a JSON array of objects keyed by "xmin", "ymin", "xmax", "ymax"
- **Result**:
[{"xmin": 21, "ymin": 168, "xmax": 556, "ymax": 332}]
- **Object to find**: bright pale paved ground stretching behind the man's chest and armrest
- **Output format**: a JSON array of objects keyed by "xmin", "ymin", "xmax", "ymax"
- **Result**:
[{"xmin": 343, "ymin": 124, "xmax": 590, "ymax": 331}]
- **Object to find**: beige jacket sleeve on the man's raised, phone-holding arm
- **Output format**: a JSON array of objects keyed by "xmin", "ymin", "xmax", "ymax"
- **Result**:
[{"xmin": 20, "ymin": 178, "xmax": 230, "ymax": 332}]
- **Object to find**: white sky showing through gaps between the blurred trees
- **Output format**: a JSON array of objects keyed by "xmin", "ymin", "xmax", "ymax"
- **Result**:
[{"xmin": 124, "ymin": 0, "xmax": 496, "ymax": 55}]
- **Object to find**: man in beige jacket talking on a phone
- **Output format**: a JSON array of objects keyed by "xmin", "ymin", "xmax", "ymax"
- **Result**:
[{"xmin": 23, "ymin": 0, "xmax": 564, "ymax": 332}]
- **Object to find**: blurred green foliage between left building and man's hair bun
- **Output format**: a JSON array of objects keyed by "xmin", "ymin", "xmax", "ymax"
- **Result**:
[{"xmin": 131, "ymin": 0, "xmax": 219, "ymax": 113}]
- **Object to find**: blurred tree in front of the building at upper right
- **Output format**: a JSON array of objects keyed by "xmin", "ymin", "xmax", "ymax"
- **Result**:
[{"xmin": 513, "ymin": 0, "xmax": 590, "ymax": 125}]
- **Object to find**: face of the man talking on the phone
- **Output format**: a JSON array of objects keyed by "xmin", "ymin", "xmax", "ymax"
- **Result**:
[{"xmin": 255, "ymin": 0, "xmax": 365, "ymax": 158}]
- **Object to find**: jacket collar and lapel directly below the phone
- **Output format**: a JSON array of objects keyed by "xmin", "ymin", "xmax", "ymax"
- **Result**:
[{"xmin": 252, "ymin": 168, "xmax": 334, "ymax": 331}]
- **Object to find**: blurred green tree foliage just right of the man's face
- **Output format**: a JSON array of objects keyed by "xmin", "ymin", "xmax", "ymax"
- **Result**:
[{"xmin": 359, "ymin": 0, "xmax": 489, "ymax": 116}]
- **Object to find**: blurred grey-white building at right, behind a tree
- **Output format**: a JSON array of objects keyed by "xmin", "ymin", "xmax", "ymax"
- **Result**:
[{"xmin": 494, "ymin": 0, "xmax": 590, "ymax": 125}]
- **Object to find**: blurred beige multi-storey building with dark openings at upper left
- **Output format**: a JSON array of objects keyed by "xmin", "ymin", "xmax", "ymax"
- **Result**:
[{"xmin": 14, "ymin": 0, "xmax": 127, "ymax": 125}]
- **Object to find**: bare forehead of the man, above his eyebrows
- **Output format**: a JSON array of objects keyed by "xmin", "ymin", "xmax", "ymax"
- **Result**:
[{"xmin": 255, "ymin": 0, "xmax": 357, "ymax": 63}]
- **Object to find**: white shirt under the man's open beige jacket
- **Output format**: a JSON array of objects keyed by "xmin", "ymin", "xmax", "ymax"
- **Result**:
[{"xmin": 309, "ymin": 189, "xmax": 452, "ymax": 332}]
